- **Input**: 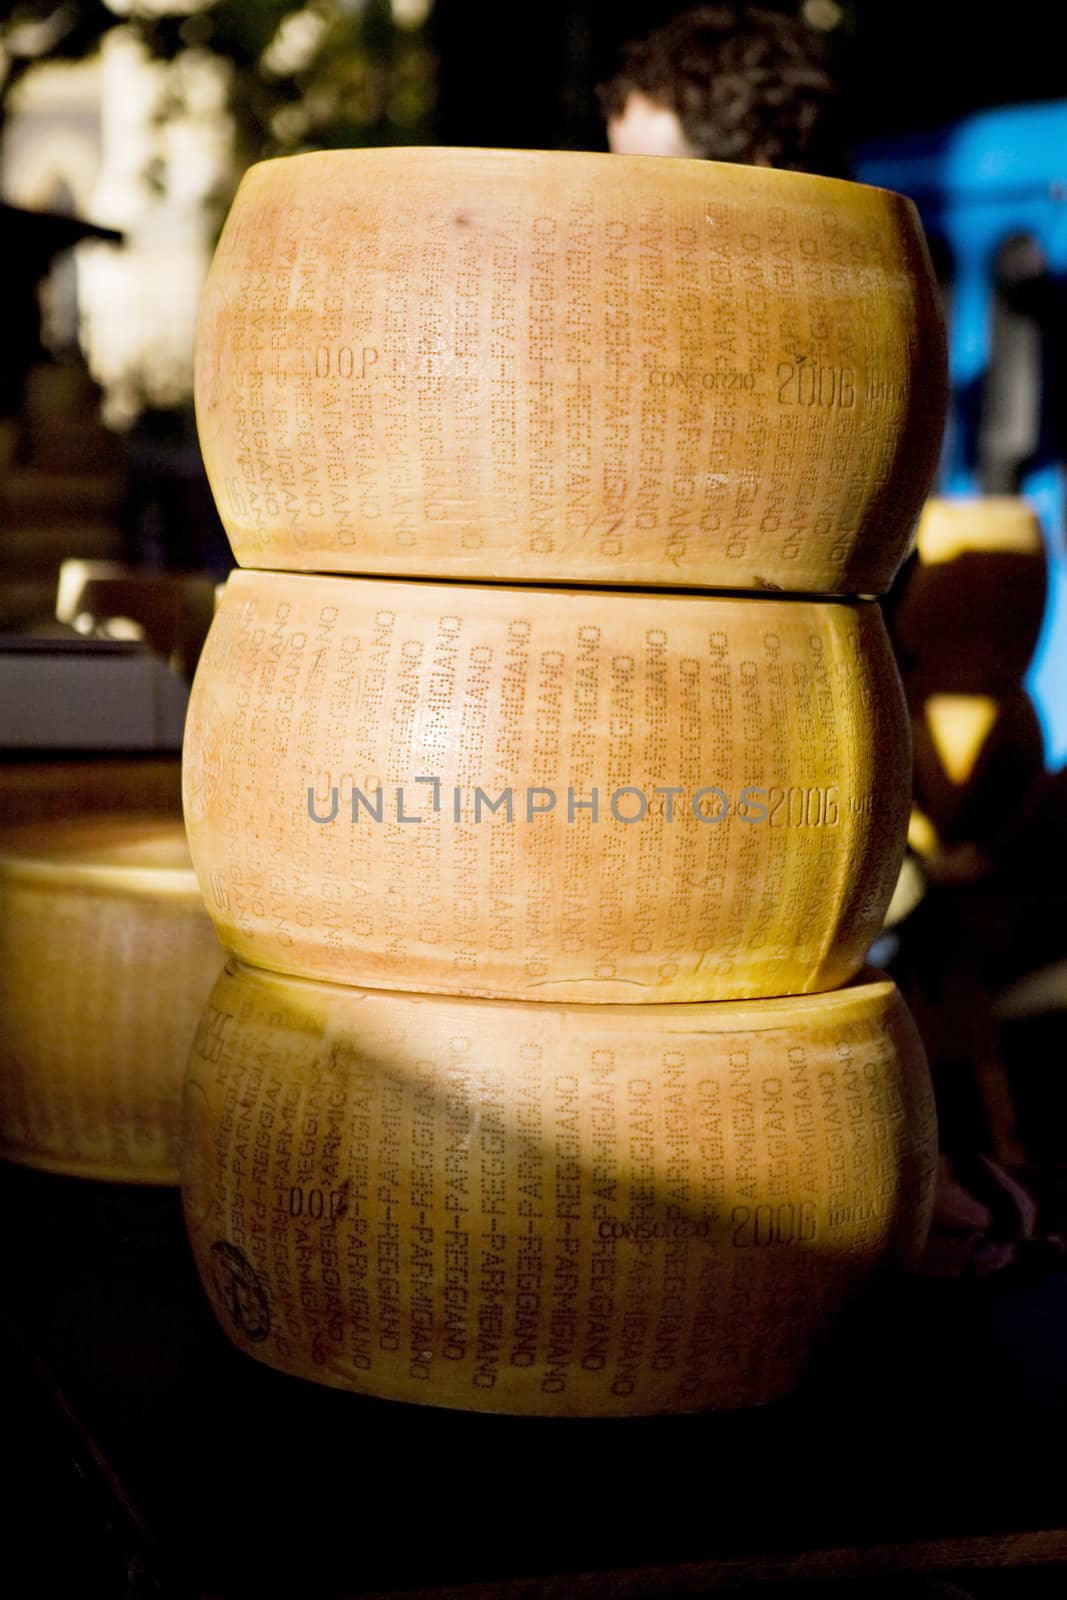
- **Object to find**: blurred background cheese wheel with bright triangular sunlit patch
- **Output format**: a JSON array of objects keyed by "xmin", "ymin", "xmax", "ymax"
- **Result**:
[{"xmin": 912, "ymin": 690, "xmax": 1045, "ymax": 858}]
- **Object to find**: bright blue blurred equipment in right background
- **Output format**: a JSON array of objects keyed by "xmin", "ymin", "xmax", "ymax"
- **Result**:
[{"xmin": 854, "ymin": 101, "xmax": 1067, "ymax": 768}]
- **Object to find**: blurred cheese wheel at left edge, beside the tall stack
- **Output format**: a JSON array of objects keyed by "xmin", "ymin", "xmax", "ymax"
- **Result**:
[{"xmin": 0, "ymin": 814, "xmax": 219, "ymax": 1184}]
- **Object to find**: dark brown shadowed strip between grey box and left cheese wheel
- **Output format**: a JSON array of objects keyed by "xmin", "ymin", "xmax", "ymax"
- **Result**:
[{"xmin": 0, "ymin": 752, "xmax": 181, "ymax": 827}]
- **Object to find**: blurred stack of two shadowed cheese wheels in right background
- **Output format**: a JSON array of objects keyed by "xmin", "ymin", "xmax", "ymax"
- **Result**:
[{"xmin": 893, "ymin": 498, "xmax": 1046, "ymax": 875}]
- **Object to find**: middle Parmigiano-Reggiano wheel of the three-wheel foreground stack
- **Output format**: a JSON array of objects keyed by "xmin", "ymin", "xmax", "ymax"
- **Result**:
[{"xmin": 184, "ymin": 573, "xmax": 910, "ymax": 1003}]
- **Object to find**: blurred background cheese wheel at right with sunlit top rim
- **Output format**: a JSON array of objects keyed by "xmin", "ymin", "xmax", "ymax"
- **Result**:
[{"xmin": 891, "ymin": 498, "xmax": 1048, "ymax": 696}]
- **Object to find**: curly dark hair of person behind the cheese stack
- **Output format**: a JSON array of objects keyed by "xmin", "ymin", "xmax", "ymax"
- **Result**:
[{"xmin": 597, "ymin": 5, "xmax": 848, "ymax": 178}]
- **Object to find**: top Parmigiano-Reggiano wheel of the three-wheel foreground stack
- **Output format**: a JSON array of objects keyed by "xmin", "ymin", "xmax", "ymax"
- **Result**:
[{"xmin": 197, "ymin": 149, "xmax": 945, "ymax": 594}]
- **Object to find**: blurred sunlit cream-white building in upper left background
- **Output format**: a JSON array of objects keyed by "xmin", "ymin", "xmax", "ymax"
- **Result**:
[{"xmin": 0, "ymin": 24, "xmax": 234, "ymax": 427}]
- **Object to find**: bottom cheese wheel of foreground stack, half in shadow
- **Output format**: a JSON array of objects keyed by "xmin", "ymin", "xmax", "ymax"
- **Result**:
[{"xmin": 182, "ymin": 962, "xmax": 936, "ymax": 1416}]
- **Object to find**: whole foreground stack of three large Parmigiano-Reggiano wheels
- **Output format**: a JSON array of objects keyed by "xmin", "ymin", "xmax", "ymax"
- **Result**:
[{"xmin": 184, "ymin": 149, "xmax": 944, "ymax": 1414}]
